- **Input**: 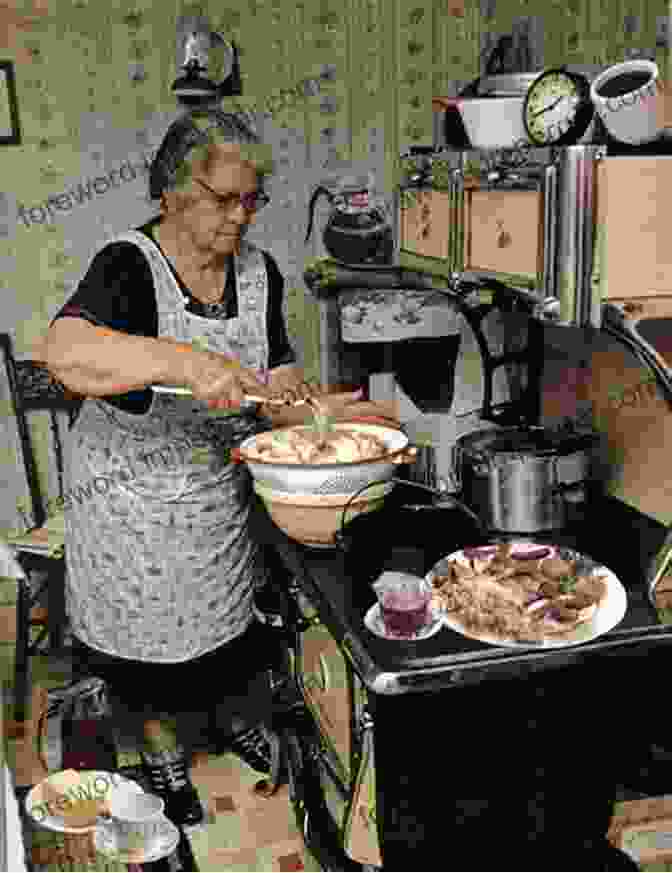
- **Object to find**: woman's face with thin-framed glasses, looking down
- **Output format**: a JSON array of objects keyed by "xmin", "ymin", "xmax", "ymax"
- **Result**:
[{"xmin": 169, "ymin": 145, "xmax": 258, "ymax": 255}]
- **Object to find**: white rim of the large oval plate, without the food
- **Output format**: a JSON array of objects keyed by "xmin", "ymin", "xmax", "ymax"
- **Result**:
[{"xmin": 426, "ymin": 543, "xmax": 628, "ymax": 649}]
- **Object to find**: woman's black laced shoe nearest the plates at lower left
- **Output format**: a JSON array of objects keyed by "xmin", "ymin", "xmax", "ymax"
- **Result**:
[{"xmin": 142, "ymin": 748, "xmax": 205, "ymax": 827}]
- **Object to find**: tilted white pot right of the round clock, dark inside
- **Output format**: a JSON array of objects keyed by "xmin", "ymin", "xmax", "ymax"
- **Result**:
[{"xmin": 590, "ymin": 59, "xmax": 660, "ymax": 145}]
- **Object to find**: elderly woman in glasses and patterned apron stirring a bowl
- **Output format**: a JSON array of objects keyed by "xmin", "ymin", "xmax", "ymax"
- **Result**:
[{"xmin": 36, "ymin": 110, "xmax": 384, "ymax": 824}]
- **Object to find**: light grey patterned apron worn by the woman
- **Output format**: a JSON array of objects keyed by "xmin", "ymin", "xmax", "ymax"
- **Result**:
[{"xmin": 64, "ymin": 231, "xmax": 269, "ymax": 663}]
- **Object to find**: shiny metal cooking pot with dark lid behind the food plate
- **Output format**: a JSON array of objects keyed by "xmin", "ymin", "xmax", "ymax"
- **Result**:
[{"xmin": 453, "ymin": 427, "xmax": 599, "ymax": 534}]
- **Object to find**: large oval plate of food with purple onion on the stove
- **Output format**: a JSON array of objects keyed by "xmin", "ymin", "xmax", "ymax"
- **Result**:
[{"xmin": 427, "ymin": 543, "xmax": 628, "ymax": 648}]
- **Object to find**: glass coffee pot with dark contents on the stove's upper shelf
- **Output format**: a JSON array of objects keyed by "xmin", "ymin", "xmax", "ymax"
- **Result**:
[{"xmin": 305, "ymin": 177, "xmax": 394, "ymax": 264}]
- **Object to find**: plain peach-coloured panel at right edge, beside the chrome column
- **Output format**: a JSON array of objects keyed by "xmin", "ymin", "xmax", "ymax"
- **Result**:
[{"xmin": 597, "ymin": 156, "xmax": 672, "ymax": 300}]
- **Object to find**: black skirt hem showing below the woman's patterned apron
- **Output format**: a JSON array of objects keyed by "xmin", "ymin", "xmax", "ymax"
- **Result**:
[{"xmin": 73, "ymin": 621, "xmax": 280, "ymax": 714}]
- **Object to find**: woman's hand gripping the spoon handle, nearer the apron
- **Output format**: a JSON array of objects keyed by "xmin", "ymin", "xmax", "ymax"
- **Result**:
[{"xmin": 185, "ymin": 351, "xmax": 271, "ymax": 409}]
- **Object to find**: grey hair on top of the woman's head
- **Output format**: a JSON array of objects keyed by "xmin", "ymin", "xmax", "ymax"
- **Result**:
[{"xmin": 149, "ymin": 109, "xmax": 272, "ymax": 200}]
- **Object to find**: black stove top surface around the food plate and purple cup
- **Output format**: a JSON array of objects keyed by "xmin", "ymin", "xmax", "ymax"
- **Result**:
[{"xmin": 292, "ymin": 486, "xmax": 672, "ymax": 693}]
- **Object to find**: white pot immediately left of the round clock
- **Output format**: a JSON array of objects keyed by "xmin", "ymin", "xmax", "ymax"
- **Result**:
[{"xmin": 456, "ymin": 97, "xmax": 529, "ymax": 149}]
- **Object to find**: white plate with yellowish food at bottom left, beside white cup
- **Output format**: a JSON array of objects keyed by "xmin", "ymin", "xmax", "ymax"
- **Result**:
[{"xmin": 25, "ymin": 770, "xmax": 143, "ymax": 834}]
